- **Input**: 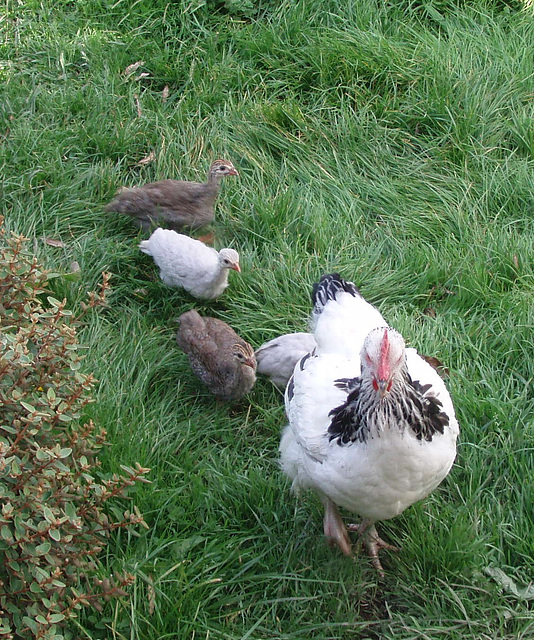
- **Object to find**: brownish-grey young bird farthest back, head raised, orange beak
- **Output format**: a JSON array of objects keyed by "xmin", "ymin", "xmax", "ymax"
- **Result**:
[{"xmin": 106, "ymin": 160, "xmax": 239, "ymax": 231}]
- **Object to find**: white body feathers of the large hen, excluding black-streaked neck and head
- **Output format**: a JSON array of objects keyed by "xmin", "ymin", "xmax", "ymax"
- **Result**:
[{"xmin": 280, "ymin": 278, "xmax": 458, "ymax": 522}]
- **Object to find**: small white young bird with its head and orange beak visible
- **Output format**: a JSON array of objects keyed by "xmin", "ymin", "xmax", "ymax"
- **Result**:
[{"xmin": 139, "ymin": 228, "xmax": 241, "ymax": 300}]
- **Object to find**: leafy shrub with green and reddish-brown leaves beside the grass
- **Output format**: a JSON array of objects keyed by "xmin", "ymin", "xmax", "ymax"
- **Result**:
[{"xmin": 0, "ymin": 219, "xmax": 148, "ymax": 639}]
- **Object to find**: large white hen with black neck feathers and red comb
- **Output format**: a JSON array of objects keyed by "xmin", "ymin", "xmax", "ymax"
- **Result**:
[{"xmin": 280, "ymin": 274, "xmax": 459, "ymax": 574}]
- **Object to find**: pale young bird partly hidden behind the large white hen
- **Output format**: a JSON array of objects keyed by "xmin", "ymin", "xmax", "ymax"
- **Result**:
[{"xmin": 256, "ymin": 333, "xmax": 316, "ymax": 390}]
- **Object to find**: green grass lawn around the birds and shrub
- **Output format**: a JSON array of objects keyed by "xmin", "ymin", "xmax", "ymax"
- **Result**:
[{"xmin": 0, "ymin": 0, "xmax": 534, "ymax": 640}]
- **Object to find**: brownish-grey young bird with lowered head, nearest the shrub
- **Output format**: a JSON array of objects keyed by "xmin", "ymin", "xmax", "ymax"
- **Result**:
[{"xmin": 176, "ymin": 309, "xmax": 256, "ymax": 400}]
